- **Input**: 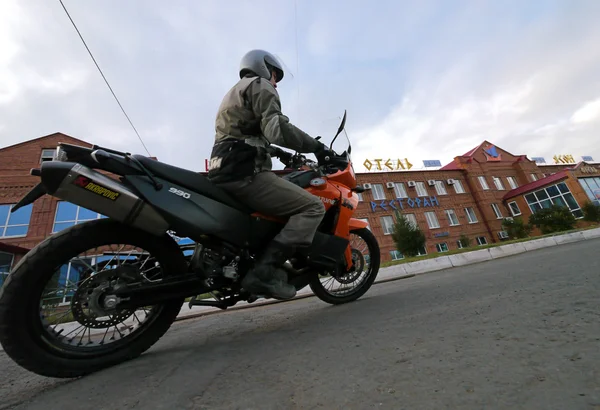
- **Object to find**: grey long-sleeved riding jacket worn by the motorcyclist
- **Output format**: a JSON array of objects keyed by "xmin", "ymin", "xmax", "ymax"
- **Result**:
[{"xmin": 209, "ymin": 77, "xmax": 320, "ymax": 172}]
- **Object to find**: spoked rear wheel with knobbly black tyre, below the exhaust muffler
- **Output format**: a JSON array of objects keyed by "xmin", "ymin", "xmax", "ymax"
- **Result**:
[{"xmin": 0, "ymin": 219, "xmax": 187, "ymax": 378}]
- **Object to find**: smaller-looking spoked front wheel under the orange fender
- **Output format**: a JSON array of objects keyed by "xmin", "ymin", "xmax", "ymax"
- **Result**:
[{"xmin": 309, "ymin": 228, "xmax": 381, "ymax": 305}]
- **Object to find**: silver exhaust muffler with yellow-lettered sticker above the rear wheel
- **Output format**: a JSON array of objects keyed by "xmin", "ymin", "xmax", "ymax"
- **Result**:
[{"xmin": 41, "ymin": 161, "xmax": 169, "ymax": 235}]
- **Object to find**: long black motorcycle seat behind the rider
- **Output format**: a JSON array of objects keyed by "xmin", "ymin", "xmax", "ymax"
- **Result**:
[{"xmin": 133, "ymin": 155, "xmax": 254, "ymax": 213}]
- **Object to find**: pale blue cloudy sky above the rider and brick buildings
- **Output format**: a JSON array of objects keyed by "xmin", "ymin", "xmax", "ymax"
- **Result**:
[{"xmin": 0, "ymin": 0, "xmax": 600, "ymax": 171}]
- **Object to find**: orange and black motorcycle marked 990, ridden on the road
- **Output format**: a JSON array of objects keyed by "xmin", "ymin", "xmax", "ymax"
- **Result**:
[{"xmin": 0, "ymin": 112, "xmax": 380, "ymax": 378}]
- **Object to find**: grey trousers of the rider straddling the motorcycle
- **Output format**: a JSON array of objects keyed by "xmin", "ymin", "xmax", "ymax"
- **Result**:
[{"xmin": 219, "ymin": 171, "xmax": 325, "ymax": 247}]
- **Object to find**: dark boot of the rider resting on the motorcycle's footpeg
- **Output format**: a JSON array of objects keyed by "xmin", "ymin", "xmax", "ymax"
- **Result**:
[{"xmin": 242, "ymin": 241, "xmax": 296, "ymax": 299}]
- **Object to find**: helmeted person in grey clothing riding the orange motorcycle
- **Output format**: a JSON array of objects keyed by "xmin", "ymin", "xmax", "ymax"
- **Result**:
[{"xmin": 208, "ymin": 50, "xmax": 330, "ymax": 299}]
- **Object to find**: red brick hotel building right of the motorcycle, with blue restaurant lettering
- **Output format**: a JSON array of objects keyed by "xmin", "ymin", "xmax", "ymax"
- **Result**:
[{"xmin": 356, "ymin": 141, "xmax": 600, "ymax": 261}]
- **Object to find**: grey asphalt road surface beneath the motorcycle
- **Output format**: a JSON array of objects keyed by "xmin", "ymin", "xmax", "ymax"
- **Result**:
[{"xmin": 0, "ymin": 240, "xmax": 600, "ymax": 410}]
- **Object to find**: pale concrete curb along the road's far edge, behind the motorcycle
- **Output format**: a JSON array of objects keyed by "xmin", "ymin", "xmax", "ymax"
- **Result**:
[{"xmin": 175, "ymin": 228, "xmax": 600, "ymax": 322}]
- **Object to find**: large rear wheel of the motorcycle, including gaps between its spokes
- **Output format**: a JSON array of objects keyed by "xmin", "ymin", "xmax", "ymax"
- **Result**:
[{"xmin": 0, "ymin": 219, "xmax": 186, "ymax": 378}]
